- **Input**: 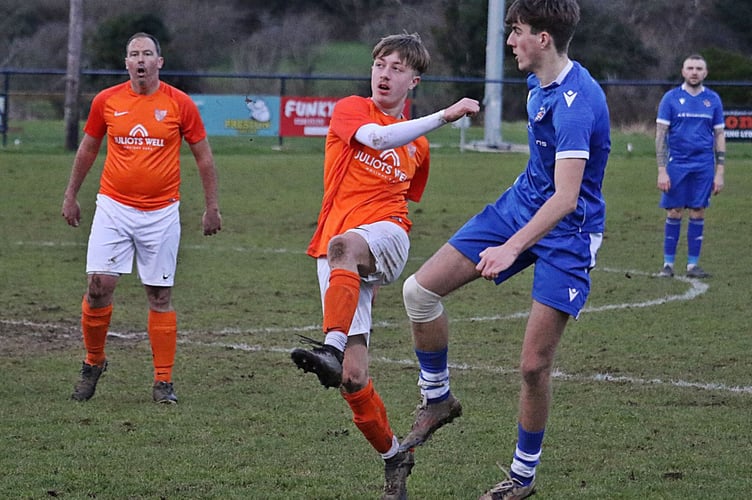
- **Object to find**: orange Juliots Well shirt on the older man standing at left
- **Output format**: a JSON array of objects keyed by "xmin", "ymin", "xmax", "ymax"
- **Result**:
[{"xmin": 84, "ymin": 82, "xmax": 206, "ymax": 210}]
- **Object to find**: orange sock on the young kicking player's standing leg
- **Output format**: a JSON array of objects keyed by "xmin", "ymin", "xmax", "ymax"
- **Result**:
[{"xmin": 342, "ymin": 380, "xmax": 394, "ymax": 454}]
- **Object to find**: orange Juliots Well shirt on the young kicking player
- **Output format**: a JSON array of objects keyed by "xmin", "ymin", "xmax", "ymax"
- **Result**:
[{"xmin": 308, "ymin": 96, "xmax": 430, "ymax": 257}]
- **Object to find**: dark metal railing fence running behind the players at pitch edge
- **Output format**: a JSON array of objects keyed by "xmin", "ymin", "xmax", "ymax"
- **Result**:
[{"xmin": 0, "ymin": 68, "xmax": 752, "ymax": 145}]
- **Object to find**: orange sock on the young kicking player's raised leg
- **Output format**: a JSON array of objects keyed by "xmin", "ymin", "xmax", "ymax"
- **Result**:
[{"xmin": 324, "ymin": 268, "xmax": 360, "ymax": 334}]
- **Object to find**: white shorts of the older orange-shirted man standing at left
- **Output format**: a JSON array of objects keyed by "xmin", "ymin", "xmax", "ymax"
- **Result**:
[{"xmin": 86, "ymin": 194, "xmax": 180, "ymax": 287}]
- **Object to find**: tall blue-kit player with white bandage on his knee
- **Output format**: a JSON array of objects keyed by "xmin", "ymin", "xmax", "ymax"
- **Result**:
[{"xmin": 401, "ymin": 0, "xmax": 611, "ymax": 499}]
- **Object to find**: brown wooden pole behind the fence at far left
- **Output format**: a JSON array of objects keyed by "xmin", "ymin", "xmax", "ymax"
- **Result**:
[{"xmin": 63, "ymin": 0, "xmax": 84, "ymax": 151}]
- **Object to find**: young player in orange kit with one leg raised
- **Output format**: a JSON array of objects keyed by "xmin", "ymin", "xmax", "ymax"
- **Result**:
[{"xmin": 292, "ymin": 33, "xmax": 479, "ymax": 499}]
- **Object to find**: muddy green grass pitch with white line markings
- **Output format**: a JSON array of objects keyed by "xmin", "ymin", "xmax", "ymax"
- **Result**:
[{"xmin": 0, "ymin": 122, "xmax": 752, "ymax": 500}]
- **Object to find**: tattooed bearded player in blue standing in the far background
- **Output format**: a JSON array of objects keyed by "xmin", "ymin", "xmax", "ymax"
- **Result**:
[{"xmin": 655, "ymin": 54, "xmax": 726, "ymax": 278}]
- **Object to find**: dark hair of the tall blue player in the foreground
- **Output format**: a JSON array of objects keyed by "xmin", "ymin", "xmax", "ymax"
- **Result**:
[{"xmin": 504, "ymin": 0, "xmax": 580, "ymax": 54}]
